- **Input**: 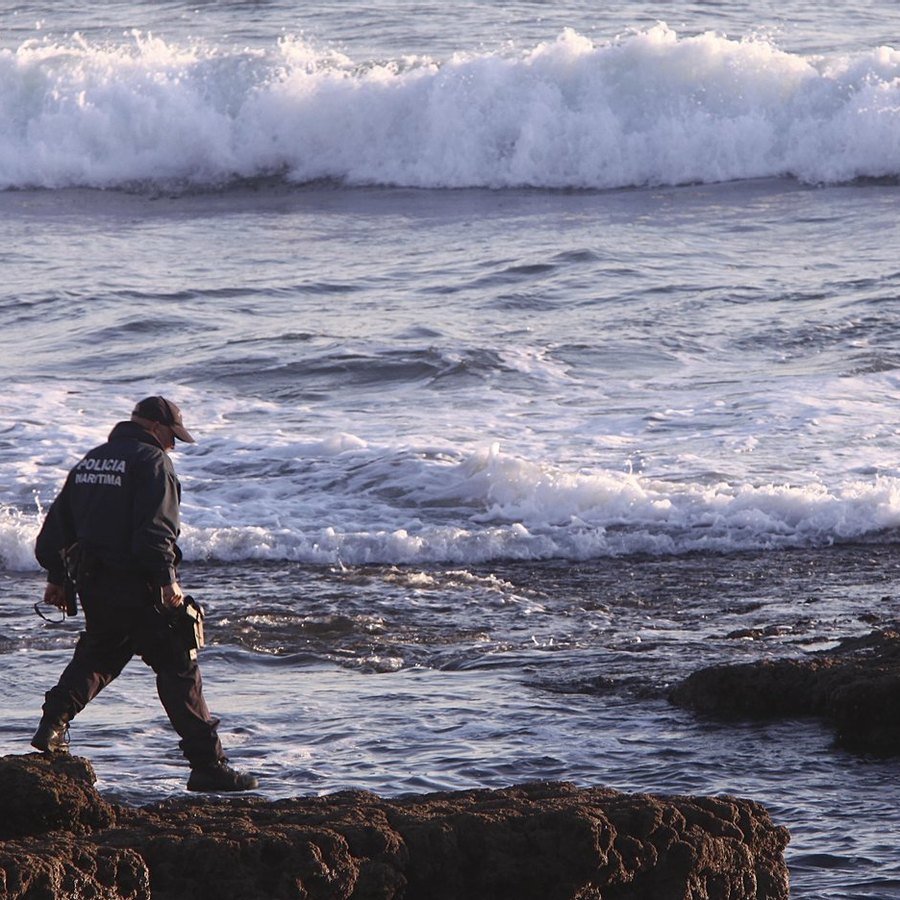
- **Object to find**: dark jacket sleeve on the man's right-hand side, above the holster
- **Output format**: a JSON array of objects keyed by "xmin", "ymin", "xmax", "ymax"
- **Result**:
[{"xmin": 131, "ymin": 454, "xmax": 181, "ymax": 587}]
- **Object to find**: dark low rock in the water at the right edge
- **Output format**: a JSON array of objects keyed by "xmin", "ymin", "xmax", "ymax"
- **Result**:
[{"xmin": 671, "ymin": 629, "xmax": 900, "ymax": 756}]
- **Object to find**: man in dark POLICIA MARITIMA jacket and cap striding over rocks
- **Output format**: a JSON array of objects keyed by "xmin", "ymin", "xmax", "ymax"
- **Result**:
[{"xmin": 31, "ymin": 397, "xmax": 258, "ymax": 791}]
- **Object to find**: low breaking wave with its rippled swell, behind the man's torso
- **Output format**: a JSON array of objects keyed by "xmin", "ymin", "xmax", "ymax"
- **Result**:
[{"xmin": 7, "ymin": 418, "xmax": 900, "ymax": 570}]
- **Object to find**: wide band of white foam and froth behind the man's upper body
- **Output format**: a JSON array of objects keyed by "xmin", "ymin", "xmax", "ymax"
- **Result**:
[{"xmin": 0, "ymin": 360, "xmax": 900, "ymax": 570}]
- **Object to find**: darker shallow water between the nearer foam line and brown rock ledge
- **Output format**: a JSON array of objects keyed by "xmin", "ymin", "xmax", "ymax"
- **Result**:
[{"xmin": 0, "ymin": 546, "xmax": 898, "ymax": 898}]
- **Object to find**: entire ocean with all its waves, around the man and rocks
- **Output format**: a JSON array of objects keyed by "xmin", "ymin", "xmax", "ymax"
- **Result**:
[{"xmin": 0, "ymin": 0, "xmax": 900, "ymax": 900}]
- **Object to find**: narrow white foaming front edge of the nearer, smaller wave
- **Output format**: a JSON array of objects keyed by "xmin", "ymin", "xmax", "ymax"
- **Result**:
[{"xmin": 0, "ymin": 473, "xmax": 900, "ymax": 570}]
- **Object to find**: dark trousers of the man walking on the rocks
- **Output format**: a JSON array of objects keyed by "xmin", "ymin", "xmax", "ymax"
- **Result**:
[{"xmin": 44, "ymin": 569, "xmax": 225, "ymax": 766}]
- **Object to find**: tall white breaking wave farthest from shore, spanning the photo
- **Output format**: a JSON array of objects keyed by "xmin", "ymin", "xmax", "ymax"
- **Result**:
[{"xmin": 0, "ymin": 24, "xmax": 900, "ymax": 190}]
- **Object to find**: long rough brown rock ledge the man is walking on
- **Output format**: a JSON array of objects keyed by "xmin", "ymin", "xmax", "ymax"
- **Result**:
[{"xmin": 0, "ymin": 754, "xmax": 788, "ymax": 900}]
